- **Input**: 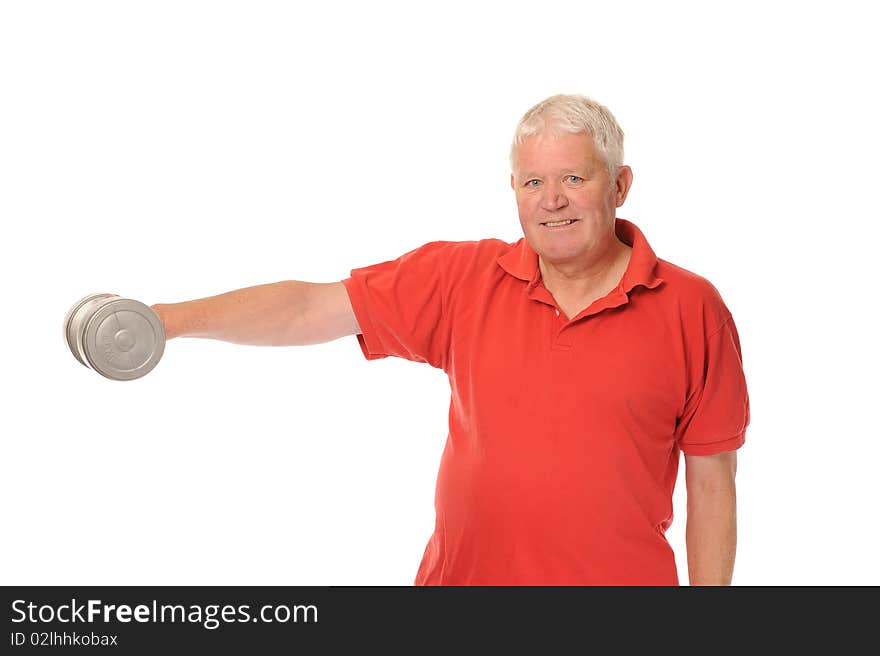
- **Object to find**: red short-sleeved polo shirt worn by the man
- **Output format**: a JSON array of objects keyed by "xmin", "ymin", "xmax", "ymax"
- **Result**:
[{"xmin": 343, "ymin": 219, "xmax": 749, "ymax": 585}]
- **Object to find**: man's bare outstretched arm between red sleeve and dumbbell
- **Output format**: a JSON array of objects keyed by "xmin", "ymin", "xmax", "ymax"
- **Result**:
[{"xmin": 151, "ymin": 280, "xmax": 360, "ymax": 346}]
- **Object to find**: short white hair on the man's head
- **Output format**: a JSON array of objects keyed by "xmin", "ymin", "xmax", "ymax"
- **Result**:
[{"xmin": 510, "ymin": 94, "xmax": 623, "ymax": 180}]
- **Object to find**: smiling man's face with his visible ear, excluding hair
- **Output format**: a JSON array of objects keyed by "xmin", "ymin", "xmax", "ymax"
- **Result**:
[{"xmin": 510, "ymin": 132, "xmax": 632, "ymax": 264}]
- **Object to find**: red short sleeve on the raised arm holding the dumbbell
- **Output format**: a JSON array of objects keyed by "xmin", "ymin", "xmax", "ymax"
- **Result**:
[{"xmin": 342, "ymin": 241, "xmax": 455, "ymax": 369}]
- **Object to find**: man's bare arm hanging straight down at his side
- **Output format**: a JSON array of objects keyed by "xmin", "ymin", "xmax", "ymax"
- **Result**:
[{"xmin": 685, "ymin": 451, "xmax": 736, "ymax": 585}]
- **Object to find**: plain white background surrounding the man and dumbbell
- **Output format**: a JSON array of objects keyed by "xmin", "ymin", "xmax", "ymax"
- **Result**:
[{"xmin": 0, "ymin": 0, "xmax": 880, "ymax": 585}]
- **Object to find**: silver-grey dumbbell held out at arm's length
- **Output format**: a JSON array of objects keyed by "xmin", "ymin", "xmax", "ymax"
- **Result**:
[{"xmin": 64, "ymin": 294, "xmax": 165, "ymax": 380}]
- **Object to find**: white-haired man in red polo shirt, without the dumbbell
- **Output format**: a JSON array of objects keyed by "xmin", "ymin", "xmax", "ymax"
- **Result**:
[{"xmin": 153, "ymin": 96, "xmax": 749, "ymax": 585}]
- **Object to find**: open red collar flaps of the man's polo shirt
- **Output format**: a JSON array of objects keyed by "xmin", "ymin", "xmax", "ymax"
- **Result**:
[{"xmin": 498, "ymin": 218, "xmax": 663, "ymax": 293}]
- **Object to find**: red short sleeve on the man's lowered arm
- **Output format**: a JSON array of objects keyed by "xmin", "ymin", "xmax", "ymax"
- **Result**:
[{"xmin": 676, "ymin": 314, "xmax": 750, "ymax": 455}]
